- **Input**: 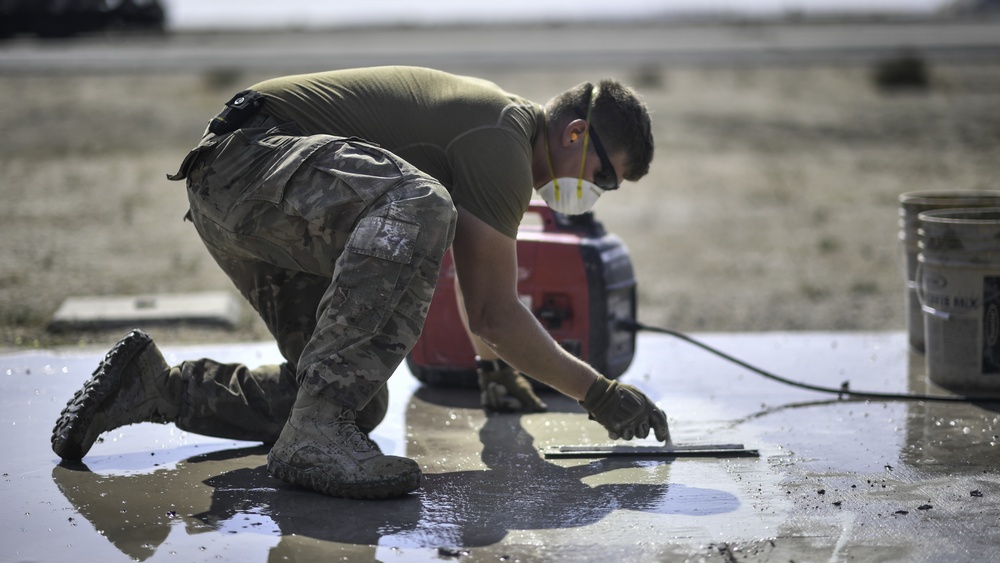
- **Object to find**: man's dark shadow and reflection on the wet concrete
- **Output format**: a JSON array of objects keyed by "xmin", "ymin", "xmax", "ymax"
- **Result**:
[{"xmin": 52, "ymin": 382, "xmax": 740, "ymax": 561}]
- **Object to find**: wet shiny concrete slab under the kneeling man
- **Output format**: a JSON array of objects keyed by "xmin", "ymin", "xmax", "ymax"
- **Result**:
[{"xmin": 0, "ymin": 331, "xmax": 1000, "ymax": 563}]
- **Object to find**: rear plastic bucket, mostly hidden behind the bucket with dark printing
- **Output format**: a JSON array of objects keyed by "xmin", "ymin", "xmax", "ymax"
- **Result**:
[{"xmin": 899, "ymin": 190, "xmax": 1000, "ymax": 352}]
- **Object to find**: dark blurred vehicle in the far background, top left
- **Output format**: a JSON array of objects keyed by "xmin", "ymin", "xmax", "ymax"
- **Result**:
[{"xmin": 0, "ymin": 0, "xmax": 165, "ymax": 37}]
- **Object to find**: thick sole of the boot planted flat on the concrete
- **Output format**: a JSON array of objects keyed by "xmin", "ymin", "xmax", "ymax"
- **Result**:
[{"xmin": 267, "ymin": 452, "xmax": 421, "ymax": 499}]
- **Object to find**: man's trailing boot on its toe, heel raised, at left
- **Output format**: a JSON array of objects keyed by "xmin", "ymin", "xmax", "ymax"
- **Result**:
[{"xmin": 52, "ymin": 330, "xmax": 180, "ymax": 461}]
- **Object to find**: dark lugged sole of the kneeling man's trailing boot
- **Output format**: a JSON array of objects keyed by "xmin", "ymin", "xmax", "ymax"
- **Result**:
[{"xmin": 52, "ymin": 330, "xmax": 153, "ymax": 461}]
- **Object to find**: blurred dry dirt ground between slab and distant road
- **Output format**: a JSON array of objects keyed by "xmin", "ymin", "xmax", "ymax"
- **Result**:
[{"xmin": 0, "ymin": 48, "xmax": 1000, "ymax": 349}]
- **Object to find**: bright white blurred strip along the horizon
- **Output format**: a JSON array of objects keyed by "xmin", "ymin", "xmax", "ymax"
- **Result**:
[{"xmin": 160, "ymin": 0, "xmax": 953, "ymax": 31}]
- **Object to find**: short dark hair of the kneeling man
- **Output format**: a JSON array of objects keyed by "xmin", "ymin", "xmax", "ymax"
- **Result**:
[{"xmin": 545, "ymin": 78, "xmax": 653, "ymax": 182}]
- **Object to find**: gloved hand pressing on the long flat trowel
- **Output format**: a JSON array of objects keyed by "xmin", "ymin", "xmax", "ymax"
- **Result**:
[{"xmin": 580, "ymin": 377, "xmax": 670, "ymax": 442}]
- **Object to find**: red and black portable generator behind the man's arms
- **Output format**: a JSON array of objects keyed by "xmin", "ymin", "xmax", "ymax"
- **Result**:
[{"xmin": 407, "ymin": 201, "xmax": 636, "ymax": 387}]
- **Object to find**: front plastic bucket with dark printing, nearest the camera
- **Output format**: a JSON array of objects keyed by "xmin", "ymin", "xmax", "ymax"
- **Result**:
[{"xmin": 916, "ymin": 207, "xmax": 1000, "ymax": 392}]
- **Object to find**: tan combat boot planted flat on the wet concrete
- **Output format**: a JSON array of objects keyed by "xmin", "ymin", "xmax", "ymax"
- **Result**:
[{"xmin": 267, "ymin": 389, "xmax": 421, "ymax": 498}]
